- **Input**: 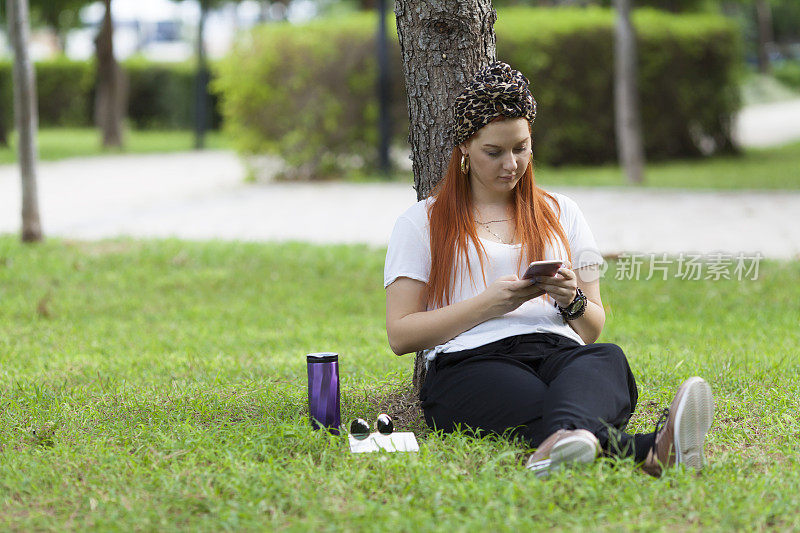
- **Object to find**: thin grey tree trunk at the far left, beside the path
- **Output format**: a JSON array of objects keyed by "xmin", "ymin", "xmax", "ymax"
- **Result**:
[{"xmin": 6, "ymin": 0, "xmax": 42, "ymax": 242}]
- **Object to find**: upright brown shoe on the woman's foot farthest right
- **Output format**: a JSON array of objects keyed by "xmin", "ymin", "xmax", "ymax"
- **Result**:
[{"xmin": 642, "ymin": 377, "xmax": 714, "ymax": 477}]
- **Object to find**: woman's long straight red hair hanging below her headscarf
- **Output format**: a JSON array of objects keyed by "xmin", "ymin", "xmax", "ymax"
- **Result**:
[{"xmin": 427, "ymin": 124, "xmax": 572, "ymax": 307}]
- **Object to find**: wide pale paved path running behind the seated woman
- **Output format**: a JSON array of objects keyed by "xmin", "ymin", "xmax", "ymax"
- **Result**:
[{"xmin": 0, "ymin": 152, "xmax": 800, "ymax": 258}]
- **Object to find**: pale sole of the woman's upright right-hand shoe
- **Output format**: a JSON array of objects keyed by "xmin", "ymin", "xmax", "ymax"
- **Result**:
[{"xmin": 674, "ymin": 377, "xmax": 714, "ymax": 472}]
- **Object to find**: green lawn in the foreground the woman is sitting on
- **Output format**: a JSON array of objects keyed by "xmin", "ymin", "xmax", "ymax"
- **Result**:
[{"xmin": 0, "ymin": 236, "xmax": 800, "ymax": 531}]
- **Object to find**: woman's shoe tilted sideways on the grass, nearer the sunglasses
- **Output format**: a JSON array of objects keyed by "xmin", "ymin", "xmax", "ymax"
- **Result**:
[{"xmin": 525, "ymin": 429, "xmax": 600, "ymax": 477}]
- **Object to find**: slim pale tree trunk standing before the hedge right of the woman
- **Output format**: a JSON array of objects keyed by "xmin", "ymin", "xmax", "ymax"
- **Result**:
[{"xmin": 614, "ymin": 0, "xmax": 644, "ymax": 184}]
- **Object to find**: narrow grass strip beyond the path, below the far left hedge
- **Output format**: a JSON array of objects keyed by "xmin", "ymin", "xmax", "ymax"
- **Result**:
[{"xmin": 0, "ymin": 128, "xmax": 229, "ymax": 164}]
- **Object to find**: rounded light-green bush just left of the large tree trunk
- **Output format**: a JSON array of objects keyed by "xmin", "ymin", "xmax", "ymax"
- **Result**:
[{"xmin": 212, "ymin": 13, "xmax": 408, "ymax": 178}]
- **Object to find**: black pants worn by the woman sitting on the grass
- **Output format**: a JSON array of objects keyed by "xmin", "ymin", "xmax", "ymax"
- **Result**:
[{"xmin": 420, "ymin": 333, "xmax": 654, "ymax": 460}]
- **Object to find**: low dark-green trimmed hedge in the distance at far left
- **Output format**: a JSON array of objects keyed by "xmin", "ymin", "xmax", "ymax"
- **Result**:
[{"xmin": 0, "ymin": 58, "xmax": 220, "ymax": 130}]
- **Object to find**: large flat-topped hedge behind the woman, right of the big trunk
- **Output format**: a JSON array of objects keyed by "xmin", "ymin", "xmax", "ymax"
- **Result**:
[{"xmin": 496, "ymin": 9, "xmax": 741, "ymax": 164}]
